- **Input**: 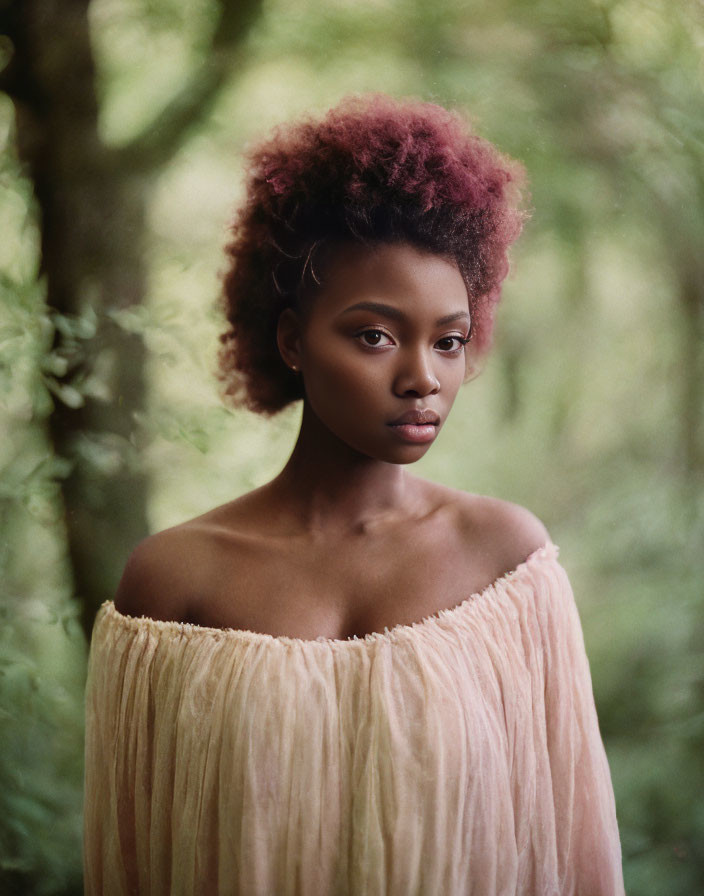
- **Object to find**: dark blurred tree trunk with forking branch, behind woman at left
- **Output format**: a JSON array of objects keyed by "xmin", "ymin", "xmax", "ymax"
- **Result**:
[{"xmin": 0, "ymin": 0, "xmax": 261, "ymax": 636}]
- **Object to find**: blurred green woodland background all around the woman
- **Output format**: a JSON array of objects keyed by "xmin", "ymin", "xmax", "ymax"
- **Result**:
[{"xmin": 0, "ymin": 0, "xmax": 704, "ymax": 896}]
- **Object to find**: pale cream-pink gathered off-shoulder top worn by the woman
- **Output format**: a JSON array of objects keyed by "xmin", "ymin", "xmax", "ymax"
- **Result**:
[{"xmin": 84, "ymin": 544, "xmax": 623, "ymax": 896}]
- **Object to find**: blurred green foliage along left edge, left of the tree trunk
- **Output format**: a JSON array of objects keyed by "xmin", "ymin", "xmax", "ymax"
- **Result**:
[{"xmin": 0, "ymin": 101, "xmax": 86, "ymax": 894}]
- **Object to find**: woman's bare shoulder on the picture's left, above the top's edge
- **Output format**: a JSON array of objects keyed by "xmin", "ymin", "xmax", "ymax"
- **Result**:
[{"xmin": 114, "ymin": 523, "xmax": 213, "ymax": 619}]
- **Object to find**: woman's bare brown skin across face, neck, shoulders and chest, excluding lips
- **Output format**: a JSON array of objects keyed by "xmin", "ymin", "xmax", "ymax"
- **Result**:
[{"xmin": 115, "ymin": 244, "xmax": 549, "ymax": 639}]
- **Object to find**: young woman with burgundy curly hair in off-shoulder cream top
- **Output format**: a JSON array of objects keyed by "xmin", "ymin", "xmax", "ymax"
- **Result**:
[{"xmin": 85, "ymin": 95, "xmax": 623, "ymax": 896}]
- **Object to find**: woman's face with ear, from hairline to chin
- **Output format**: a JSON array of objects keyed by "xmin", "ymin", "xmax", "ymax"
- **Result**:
[{"xmin": 280, "ymin": 244, "xmax": 470, "ymax": 463}]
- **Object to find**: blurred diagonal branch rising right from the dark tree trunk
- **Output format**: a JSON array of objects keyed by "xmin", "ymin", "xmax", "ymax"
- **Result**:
[{"xmin": 115, "ymin": 0, "xmax": 262, "ymax": 172}]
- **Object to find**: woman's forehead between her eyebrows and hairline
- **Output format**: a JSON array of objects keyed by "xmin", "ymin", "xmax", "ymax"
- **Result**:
[{"xmin": 310, "ymin": 243, "xmax": 469, "ymax": 317}]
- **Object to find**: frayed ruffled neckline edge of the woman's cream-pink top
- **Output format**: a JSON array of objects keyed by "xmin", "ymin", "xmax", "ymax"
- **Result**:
[{"xmin": 99, "ymin": 542, "xmax": 559, "ymax": 649}]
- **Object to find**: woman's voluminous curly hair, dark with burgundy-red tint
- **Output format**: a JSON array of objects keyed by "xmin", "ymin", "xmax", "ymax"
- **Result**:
[{"xmin": 220, "ymin": 94, "xmax": 525, "ymax": 414}]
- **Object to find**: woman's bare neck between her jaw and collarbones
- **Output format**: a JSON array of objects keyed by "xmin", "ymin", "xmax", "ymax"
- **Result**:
[{"xmin": 272, "ymin": 405, "xmax": 414, "ymax": 534}]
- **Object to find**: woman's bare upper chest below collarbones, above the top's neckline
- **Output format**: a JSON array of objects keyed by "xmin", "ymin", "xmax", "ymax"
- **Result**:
[{"xmin": 191, "ymin": 528, "xmax": 494, "ymax": 640}]
